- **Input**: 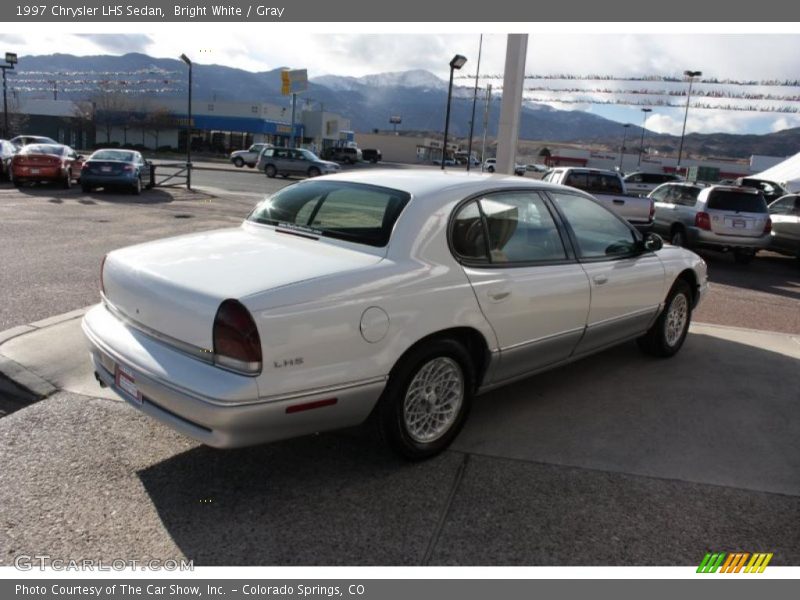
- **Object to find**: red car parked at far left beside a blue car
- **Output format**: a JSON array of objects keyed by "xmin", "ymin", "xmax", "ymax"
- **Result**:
[{"xmin": 11, "ymin": 144, "xmax": 83, "ymax": 188}]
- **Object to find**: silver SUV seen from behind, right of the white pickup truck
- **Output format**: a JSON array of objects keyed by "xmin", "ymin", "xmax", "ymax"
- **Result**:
[{"xmin": 649, "ymin": 183, "xmax": 772, "ymax": 264}]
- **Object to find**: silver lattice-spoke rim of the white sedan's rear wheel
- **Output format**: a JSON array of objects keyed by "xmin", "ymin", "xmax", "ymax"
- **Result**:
[{"xmin": 403, "ymin": 356, "xmax": 464, "ymax": 444}]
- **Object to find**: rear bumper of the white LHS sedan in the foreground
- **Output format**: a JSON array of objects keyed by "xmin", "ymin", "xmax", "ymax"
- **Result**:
[{"xmin": 83, "ymin": 305, "xmax": 385, "ymax": 448}]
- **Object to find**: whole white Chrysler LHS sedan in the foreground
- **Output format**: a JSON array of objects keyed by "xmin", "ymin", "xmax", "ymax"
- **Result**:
[{"xmin": 83, "ymin": 170, "xmax": 707, "ymax": 458}]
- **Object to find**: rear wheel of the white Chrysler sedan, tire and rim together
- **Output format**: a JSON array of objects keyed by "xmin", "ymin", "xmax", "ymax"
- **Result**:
[{"xmin": 378, "ymin": 339, "xmax": 475, "ymax": 460}]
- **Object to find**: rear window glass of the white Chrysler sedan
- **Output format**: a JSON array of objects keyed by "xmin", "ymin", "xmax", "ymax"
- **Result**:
[{"xmin": 247, "ymin": 181, "xmax": 411, "ymax": 247}]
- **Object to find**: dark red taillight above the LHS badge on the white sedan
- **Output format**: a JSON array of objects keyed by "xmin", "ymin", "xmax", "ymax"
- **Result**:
[{"xmin": 213, "ymin": 299, "xmax": 261, "ymax": 375}]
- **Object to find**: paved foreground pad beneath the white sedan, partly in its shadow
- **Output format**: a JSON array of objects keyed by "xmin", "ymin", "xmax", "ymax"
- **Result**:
[{"xmin": 0, "ymin": 315, "xmax": 800, "ymax": 565}]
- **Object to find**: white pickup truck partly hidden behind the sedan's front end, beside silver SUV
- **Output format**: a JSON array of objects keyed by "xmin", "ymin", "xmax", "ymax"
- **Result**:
[{"xmin": 542, "ymin": 167, "xmax": 655, "ymax": 233}]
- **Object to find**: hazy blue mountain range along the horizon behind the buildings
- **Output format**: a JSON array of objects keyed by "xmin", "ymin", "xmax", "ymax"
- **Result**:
[{"xmin": 9, "ymin": 53, "xmax": 800, "ymax": 158}]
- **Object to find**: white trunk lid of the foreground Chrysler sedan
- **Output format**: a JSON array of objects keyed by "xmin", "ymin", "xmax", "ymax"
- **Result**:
[{"xmin": 103, "ymin": 224, "xmax": 382, "ymax": 350}]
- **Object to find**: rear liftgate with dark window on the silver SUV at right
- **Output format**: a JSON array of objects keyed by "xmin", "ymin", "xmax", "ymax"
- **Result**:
[{"xmin": 706, "ymin": 188, "xmax": 769, "ymax": 238}]
